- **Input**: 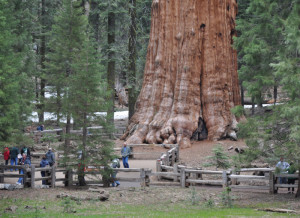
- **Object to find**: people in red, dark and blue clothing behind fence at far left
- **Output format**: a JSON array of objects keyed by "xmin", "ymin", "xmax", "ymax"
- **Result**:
[{"xmin": 3, "ymin": 146, "xmax": 55, "ymax": 185}]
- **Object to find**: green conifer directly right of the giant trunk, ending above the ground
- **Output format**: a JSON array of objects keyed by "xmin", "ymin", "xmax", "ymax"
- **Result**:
[{"xmin": 235, "ymin": 0, "xmax": 287, "ymax": 107}]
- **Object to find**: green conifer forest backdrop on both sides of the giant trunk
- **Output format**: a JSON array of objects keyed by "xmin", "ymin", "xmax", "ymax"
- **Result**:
[{"xmin": 0, "ymin": 0, "xmax": 300, "ymax": 172}]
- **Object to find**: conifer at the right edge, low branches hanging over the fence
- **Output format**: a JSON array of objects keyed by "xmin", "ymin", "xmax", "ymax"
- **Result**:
[{"xmin": 239, "ymin": 0, "xmax": 300, "ymax": 196}]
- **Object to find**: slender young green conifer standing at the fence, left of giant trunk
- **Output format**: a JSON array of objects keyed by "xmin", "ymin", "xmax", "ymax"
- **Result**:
[{"xmin": 47, "ymin": 0, "xmax": 112, "ymax": 185}]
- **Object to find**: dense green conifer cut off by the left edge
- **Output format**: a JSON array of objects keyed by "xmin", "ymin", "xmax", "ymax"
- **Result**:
[{"xmin": 0, "ymin": 1, "xmax": 34, "ymax": 146}]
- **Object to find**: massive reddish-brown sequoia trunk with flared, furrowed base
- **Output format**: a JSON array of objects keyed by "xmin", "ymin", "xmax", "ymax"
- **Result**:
[{"xmin": 123, "ymin": 0, "xmax": 240, "ymax": 147}]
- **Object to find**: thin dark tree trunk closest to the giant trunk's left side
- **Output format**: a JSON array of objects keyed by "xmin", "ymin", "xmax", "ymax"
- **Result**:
[{"xmin": 128, "ymin": 0, "xmax": 136, "ymax": 119}]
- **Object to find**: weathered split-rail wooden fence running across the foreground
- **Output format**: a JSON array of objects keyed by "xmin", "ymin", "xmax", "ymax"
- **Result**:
[{"xmin": 0, "ymin": 144, "xmax": 299, "ymax": 194}]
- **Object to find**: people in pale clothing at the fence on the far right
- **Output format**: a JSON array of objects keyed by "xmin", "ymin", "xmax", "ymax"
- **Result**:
[{"xmin": 276, "ymin": 157, "xmax": 296, "ymax": 193}]
